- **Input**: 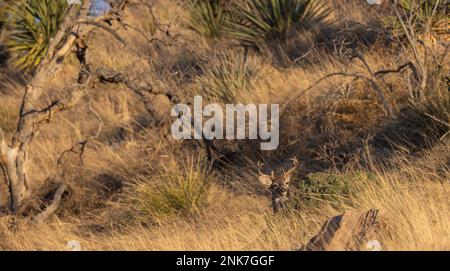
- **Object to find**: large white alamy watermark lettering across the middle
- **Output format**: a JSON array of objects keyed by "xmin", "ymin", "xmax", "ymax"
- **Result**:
[{"xmin": 171, "ymin": 96, "xmax": 280, "ymax": 150}]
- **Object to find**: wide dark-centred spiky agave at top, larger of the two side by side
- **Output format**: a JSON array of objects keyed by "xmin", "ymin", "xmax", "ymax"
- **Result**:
[{"xmin": 230, "ymin": 0, "xmax": 330, "ymax": 47}]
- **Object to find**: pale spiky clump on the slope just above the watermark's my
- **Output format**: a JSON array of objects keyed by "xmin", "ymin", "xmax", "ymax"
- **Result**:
[{"xmin": 197, "ymin": 51, "xmax": 262, "ymax": 103}]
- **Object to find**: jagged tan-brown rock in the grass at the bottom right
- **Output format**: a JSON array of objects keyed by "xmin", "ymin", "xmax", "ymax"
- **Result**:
[{"xmin": 300, "ymin": 209, "xmax": 390, "ymax": 251}]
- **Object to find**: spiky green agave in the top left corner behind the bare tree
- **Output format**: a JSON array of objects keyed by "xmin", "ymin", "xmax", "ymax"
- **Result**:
[{"xmin": 6, "ymin": 0, "xmax": 67, "ymax": 70}]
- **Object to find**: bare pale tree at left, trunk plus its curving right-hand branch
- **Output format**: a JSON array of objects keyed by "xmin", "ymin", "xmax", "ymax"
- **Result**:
[{"xmin": 0, "ymin": 0, "xmax": 131, "ymax": 214}]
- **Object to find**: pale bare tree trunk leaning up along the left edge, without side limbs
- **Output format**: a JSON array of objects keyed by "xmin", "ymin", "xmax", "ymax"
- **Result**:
[{"xmin": 0, "ymin": 0, "xmax": 91, "ymax": 214}]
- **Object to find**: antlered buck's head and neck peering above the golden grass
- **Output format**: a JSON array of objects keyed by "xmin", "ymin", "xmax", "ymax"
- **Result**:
[{"xmin": 258, "ymin": 157, "xmax": 298, "ymax": 213}]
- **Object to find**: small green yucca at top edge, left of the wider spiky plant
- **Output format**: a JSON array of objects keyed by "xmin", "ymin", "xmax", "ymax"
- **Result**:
[{"xmin": 188, "ymin": 0, "xmax": 229, "ymax": 38}]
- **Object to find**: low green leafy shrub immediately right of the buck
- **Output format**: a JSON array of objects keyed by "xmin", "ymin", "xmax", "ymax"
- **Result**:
[{"xmin": 293, "ymin": 173, "xmax": 371, "ymax": 209}]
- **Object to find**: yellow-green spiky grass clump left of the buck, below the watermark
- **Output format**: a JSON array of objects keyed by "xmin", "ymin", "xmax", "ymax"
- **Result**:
[{"xmin": 136, "ymin": 159, "xmax": 214, "ymax": 218}]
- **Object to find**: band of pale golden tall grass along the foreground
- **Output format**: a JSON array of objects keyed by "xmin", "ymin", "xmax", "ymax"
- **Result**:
[{"xmin": 0, "ymin": 147, "xmax": 450, "ymax": 250}]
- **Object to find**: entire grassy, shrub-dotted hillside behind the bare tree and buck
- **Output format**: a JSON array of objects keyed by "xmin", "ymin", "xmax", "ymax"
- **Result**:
[{"xmin": 0, "ymin": 0, "xmax": 450, "ymax": 250}]
